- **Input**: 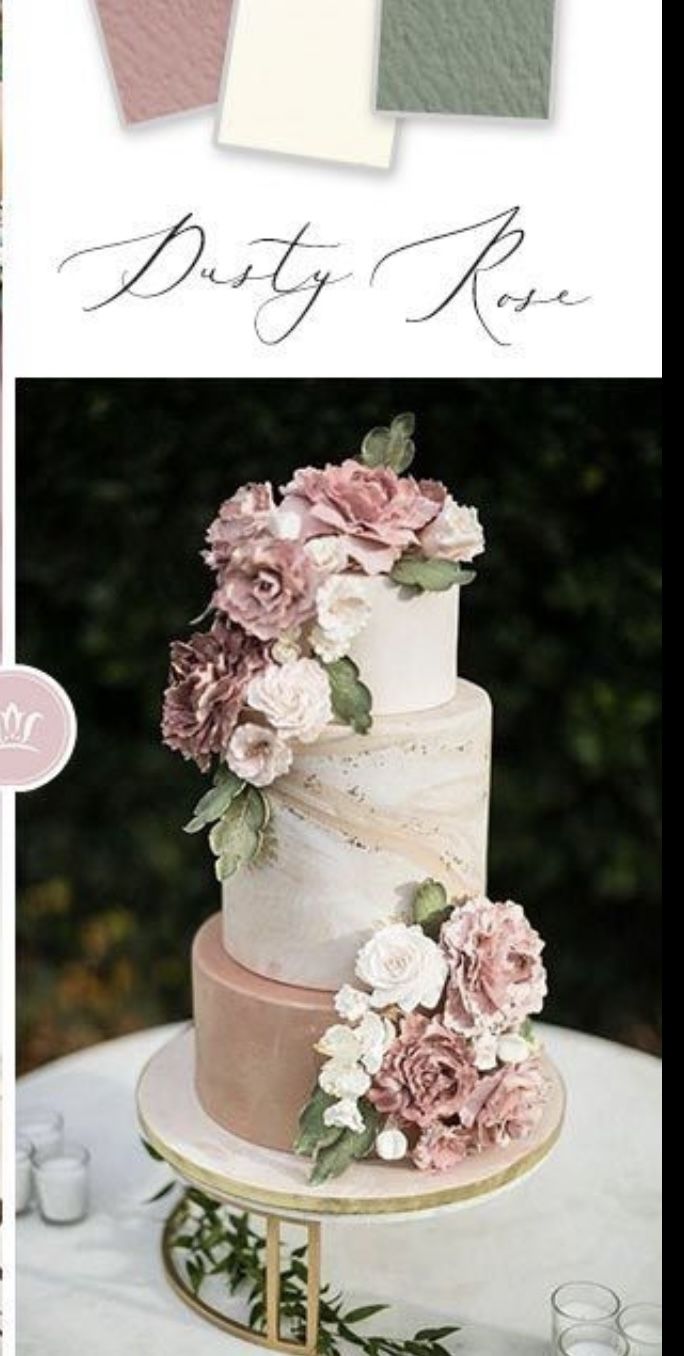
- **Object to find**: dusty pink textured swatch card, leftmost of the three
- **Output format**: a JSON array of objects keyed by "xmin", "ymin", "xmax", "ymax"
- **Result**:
[{"xmin": 95, "ymin": 0, "xmax": 231, "ymax": 122}]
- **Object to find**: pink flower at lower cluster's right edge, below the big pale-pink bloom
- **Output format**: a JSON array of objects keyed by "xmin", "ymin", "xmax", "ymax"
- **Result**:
[{"xmin": 460, "ymin": 1059, "xmax": 547, "ymax": 1149}]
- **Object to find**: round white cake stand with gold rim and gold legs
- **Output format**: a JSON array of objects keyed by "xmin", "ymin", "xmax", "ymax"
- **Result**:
[{"xmin": 137, "ymin": 1026, "xmax": 566, "ymax": 1356}]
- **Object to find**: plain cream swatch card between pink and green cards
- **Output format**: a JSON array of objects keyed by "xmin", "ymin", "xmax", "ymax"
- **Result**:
[{"xmin": 219, "ymin": 0, "xmax": 395, "ymax": 168}]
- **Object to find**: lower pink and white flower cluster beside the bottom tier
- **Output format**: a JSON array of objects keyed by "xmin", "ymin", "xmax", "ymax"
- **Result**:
[{"xmin": 295, "ymin": 880, "xmax": 548, "ymax": 1182}]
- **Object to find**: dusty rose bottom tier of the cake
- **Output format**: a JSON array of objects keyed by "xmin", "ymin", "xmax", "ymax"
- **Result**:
[{"xmin": 193, "ymin": 914, "xmax": 334, "ymax": 1150}]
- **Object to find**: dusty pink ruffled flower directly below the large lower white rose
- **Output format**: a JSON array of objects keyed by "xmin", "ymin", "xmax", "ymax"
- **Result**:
[{"xmin": 368, "ymin": 1013, "xmax": 478, "ymax": 1128}]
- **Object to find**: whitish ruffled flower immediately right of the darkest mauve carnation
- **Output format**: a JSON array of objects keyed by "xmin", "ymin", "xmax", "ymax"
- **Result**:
[{"xmin": 247, "ymin": 659, "xmax": 333, "ymax": 744}]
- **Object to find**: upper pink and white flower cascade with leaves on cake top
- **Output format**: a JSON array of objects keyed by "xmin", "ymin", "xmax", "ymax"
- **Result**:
[{"xmin": 163, "ymin": 414, "xmax": 485, "ymax": 881}]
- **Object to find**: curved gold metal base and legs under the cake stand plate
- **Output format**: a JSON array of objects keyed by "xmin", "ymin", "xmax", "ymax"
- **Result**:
[{"xmin": 162, "ymin": 1199, "xmax": 320, "ymax": 1356}]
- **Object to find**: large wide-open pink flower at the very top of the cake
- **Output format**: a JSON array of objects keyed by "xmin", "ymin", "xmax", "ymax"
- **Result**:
[{"xmin": 284, "ymin": 460, "xmax": 440, "ymax": 575}]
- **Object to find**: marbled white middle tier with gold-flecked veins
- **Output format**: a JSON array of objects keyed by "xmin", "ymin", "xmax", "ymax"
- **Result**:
[{"xmin": 223, "ymin": 679, "xmax": 491, "ymax": 990}]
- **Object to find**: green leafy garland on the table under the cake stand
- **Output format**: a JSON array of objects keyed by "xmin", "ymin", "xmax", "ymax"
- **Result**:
[{"xmin": 155, "ymin": 1187, "xmax": 459, "ymax": 1356}]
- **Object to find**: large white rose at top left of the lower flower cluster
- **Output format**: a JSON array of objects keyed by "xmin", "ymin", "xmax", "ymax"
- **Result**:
[{"xmin": 356, "ymin": 923, "xmax": 447, "ymax": 1013}]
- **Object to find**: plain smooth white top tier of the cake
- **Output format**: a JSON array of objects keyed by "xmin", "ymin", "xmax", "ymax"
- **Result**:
[{"xmin": 349, "ymin": 575, "xmax": 460, "ymax": 716}]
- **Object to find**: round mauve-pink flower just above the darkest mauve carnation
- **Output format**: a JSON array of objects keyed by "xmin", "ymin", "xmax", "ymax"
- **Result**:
[{"xmin": 213, "ymin": 536, "xmax": 319, "ymax": 640}]
